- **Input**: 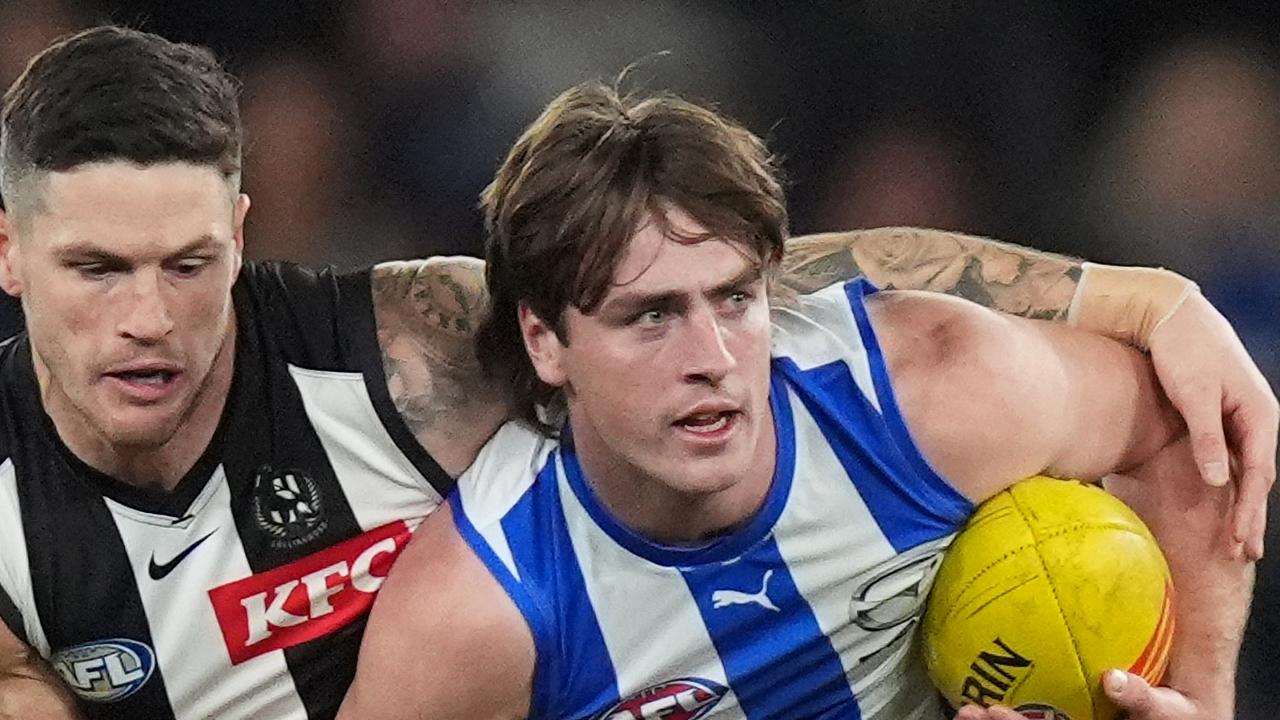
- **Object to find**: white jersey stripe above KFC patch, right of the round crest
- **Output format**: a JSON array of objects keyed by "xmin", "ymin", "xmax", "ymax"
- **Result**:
[{"xmin": 289, "ymin": 365, "xmax": 442, "ymax": 530}]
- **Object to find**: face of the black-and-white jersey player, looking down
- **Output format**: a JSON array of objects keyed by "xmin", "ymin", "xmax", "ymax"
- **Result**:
[{"xmin": 0, "ymin": 161, "xmax": 248, "ymax": 448}]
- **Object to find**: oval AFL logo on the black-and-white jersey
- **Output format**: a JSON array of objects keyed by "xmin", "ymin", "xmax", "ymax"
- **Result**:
[{"xmin": 49, "ymin": 638, "xmax": 156, "ymax": 702}]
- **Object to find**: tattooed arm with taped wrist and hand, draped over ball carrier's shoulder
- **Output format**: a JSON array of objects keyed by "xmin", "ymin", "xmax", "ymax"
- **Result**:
[{"xmin": 773, "ymin": 228, "xmax": 1280, "ymax": 550}]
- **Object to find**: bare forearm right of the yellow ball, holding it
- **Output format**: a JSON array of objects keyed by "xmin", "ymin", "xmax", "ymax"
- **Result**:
[{"xmin": 1108, "ymin": 441, "xmax": 1253, "ymax": 717}]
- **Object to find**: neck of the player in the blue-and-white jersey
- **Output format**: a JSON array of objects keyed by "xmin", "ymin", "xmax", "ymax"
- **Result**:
[{"xmin": 577, "ymin": 432, "xmax": 777, "ymax": 546}]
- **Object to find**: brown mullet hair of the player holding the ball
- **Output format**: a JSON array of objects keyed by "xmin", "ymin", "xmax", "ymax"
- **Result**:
[{"xmin": 477, "ymin": 82, "xmax": 787, "ymax": 429}]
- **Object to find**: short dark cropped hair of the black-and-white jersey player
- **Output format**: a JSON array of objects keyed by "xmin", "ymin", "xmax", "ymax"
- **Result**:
[{"xmin": 0, "ymin": 26, "xmax": 242, "ymax": 210}]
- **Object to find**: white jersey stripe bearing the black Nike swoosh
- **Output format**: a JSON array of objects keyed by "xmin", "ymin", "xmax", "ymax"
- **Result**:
[{"xmin": 105, "ymin": 466, "xmax": 307, "ymax": 720}]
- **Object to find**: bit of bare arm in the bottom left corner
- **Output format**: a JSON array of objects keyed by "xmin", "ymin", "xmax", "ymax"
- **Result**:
[{"xmin": 0, "ymin": 623, "xmax": 79, "ymax": 720}]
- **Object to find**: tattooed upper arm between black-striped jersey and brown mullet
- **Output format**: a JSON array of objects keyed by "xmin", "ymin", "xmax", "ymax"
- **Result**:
[{"xmin": 370, "ymin": 256, "xmax": 506, "ymax": 475}]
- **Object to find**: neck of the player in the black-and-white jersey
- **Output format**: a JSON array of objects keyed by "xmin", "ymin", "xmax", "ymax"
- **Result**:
[{"xmin": 33, "ymin": 319, "xmax": 236, "ymax": 492}]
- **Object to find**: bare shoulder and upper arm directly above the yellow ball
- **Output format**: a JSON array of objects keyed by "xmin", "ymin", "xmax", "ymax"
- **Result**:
[{"xmin": 868, "ymin": 285, "xmax": 1183, "ymax": 502}]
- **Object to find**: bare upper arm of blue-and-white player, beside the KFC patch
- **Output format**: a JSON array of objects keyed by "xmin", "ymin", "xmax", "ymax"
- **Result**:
[{"xmin": 338, "ymin": 505, "xmax": 534, "ymax": 720}]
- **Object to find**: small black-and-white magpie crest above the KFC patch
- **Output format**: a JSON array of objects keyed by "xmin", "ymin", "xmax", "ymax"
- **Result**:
[{"xmin": 253, "ymin": 465, "xmax": 329, "ymax": 548}]
